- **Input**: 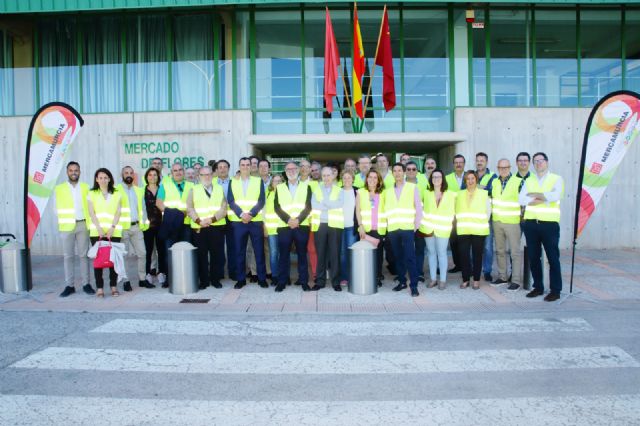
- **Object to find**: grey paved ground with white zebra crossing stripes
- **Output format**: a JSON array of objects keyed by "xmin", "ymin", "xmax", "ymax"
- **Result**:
[{"xmin": 0, "ymin": 250, "xmax": 640, "ymax": 426}]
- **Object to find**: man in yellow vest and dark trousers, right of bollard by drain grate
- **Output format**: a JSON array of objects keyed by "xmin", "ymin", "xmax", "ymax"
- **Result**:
[{"xmin": 187, "ymin": 166, "xmax": 227, "ymax": 290}]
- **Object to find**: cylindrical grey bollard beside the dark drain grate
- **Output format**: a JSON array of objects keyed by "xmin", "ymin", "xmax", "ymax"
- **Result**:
[{"xmin": 169, "ymin": 241, "xmax": 198, "ymax": 295}]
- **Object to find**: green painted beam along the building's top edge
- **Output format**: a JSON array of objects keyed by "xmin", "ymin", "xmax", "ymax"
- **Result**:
[{"xmin": 0, "ymin": 0, "xmax": 640, "ymax": 14}]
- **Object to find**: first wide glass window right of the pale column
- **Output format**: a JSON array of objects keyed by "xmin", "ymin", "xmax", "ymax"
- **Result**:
[{"xmin": 489, "ymin": 9, "xmax": 533, "ymax": 107}]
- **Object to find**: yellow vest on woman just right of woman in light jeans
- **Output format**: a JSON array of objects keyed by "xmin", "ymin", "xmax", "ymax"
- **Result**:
[{"xmin": 456, "ymin": 188, "xmax": 489, "ymax": 235}]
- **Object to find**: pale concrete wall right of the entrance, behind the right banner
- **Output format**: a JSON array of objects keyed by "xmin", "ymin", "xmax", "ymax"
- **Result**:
[{"xmin": 456, "ymin": 108, "xmax": 640, "ymax": 248}]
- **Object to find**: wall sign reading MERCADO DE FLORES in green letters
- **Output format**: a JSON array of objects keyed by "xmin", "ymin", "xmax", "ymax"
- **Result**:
[{"xmin": 118, "ymin": 130, "xmax": 223, "ymax": 173}]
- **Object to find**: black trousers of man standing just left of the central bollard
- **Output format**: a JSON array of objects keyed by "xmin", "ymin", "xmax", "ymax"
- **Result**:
[{"xmin": 313, "ymin": 223, "xmax": 342, "ymax": 286}]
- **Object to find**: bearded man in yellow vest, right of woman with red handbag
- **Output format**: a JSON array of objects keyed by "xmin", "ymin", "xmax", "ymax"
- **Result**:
[{"xmin": 116, "ymin": 166, "xmax": 155, "ymax": 291}]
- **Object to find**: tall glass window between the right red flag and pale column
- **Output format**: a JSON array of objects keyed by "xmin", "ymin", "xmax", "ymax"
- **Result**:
[{"xmin": 404, "ymin": 9, "xmax": 449, "ymax": 107}]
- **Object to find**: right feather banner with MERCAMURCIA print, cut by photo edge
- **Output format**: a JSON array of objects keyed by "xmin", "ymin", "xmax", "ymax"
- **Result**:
[{"xmin": 576, "ymin": 91, "xmax": 640, "ymax": 237}]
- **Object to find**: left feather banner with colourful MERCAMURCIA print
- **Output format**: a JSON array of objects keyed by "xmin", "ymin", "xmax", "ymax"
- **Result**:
[{"xmin": 26, "ymin": 102, "xmax": 84, "ymax": 247}]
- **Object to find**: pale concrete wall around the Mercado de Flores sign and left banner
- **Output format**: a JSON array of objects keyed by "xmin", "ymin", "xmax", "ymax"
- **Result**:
[{"xmin": 0, "ymin": 111, "xmax": 252, "ymax": 254}]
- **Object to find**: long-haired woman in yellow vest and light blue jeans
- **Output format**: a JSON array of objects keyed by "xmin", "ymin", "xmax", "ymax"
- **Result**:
[{"xmin": 420, "ymin": 169, "xmax": 457, "ymax": 290}]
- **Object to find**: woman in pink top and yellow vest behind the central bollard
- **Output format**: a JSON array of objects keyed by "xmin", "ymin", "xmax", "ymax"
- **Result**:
[{"xmin": 356, "ymin": 170, "xmax": 387, "ymax": 287}]
